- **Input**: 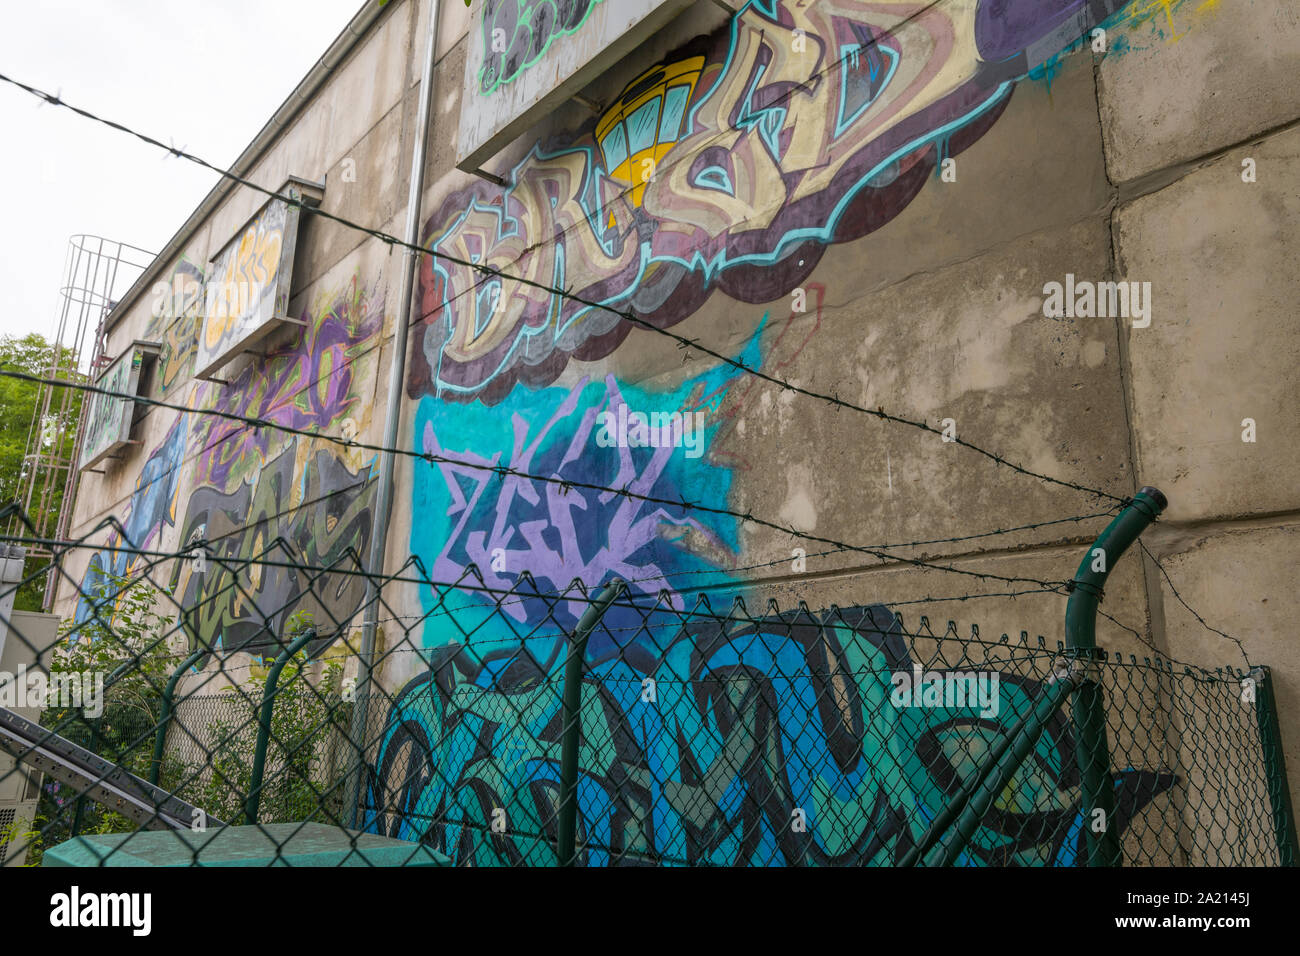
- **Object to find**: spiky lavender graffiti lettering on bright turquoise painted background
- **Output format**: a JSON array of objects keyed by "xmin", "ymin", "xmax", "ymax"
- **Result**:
[{"xmin": 411, "ymin": 326, "xmax": 763, "ymax": 656}]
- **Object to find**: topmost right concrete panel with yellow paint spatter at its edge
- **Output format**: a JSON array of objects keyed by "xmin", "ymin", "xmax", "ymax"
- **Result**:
[{"xmin": 1099, "ymin": 0, "xmax": 1300, "ymax": 182}]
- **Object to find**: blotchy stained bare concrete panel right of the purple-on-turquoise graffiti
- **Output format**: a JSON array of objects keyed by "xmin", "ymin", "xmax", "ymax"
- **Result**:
[{"xmin": 644, "ymin": 219, "xmax": 1131, "ymax": 568}]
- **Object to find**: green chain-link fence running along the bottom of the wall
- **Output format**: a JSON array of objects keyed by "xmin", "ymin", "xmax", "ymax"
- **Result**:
[{"xmin": 0, "ymin": 509, "xmax": 1295, "ymax": 866}]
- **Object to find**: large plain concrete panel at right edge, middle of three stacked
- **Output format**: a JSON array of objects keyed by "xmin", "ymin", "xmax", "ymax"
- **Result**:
[{"xmin": 1115, "ymin": 130, "xmax": 1300, "ymax": 520}]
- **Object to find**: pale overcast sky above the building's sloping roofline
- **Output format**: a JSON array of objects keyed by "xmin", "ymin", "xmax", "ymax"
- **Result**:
[{"xmin": 0, "ymin": 0, "xmax": 361, "ymax": 336}]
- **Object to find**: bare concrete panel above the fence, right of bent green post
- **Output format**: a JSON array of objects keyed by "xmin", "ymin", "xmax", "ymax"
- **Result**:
[{"xmin": 1161, "ymin": 523, "xmax": 1300, "ymax": 822}]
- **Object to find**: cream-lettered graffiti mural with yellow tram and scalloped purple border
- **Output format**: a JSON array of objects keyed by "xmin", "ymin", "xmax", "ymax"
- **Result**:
[{"xmin": 408, "ymin": 0, "xmax": 1159, "ymax": 405}]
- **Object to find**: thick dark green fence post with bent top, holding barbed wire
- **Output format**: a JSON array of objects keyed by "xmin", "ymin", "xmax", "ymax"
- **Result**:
[{"xmin": 1065, "ymin": 486, "xmax": 1169, "ymax": 866}]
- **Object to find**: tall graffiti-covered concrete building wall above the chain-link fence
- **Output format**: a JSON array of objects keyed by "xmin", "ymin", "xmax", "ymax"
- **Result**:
[{"xmin": 61, "ymin": 0, "xmax": 1300, "ymax": 862}]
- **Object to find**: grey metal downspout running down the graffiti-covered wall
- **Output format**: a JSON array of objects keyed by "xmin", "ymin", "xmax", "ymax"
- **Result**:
[{"xmin": 345, "ymin": 0, "xmax": 441, "ymax": 827}]
